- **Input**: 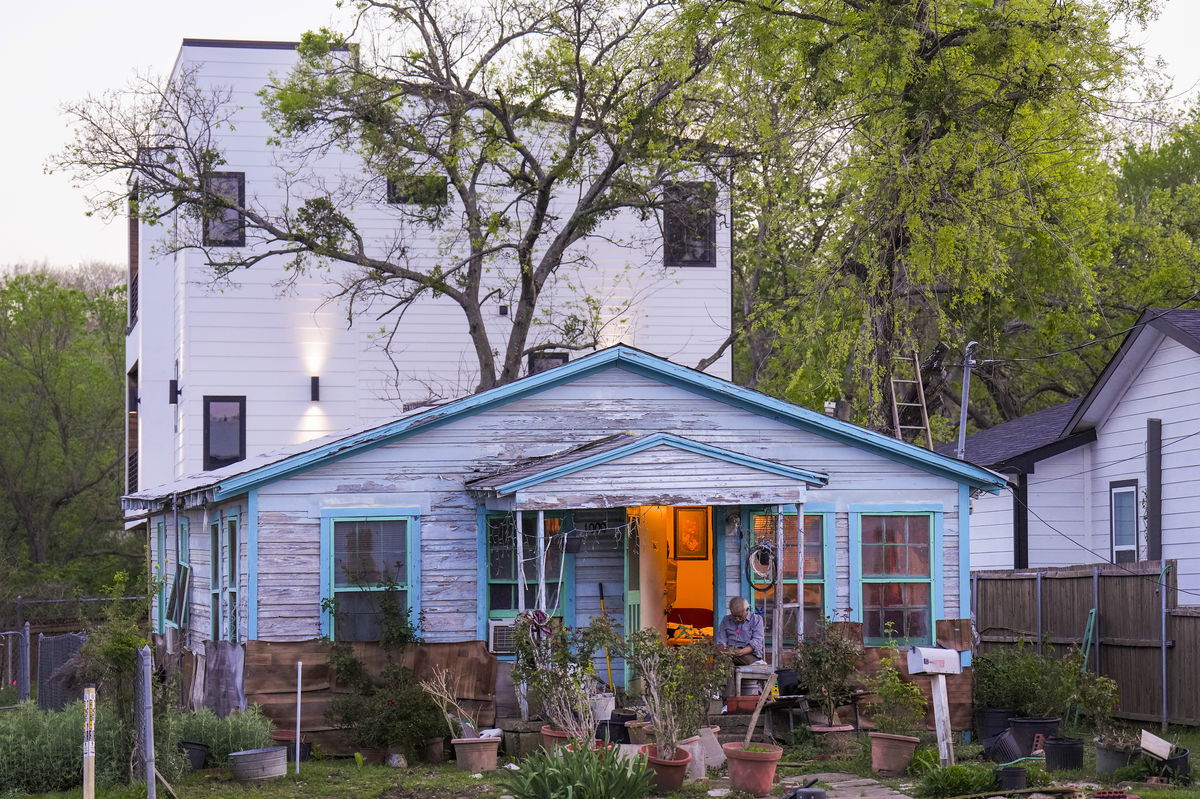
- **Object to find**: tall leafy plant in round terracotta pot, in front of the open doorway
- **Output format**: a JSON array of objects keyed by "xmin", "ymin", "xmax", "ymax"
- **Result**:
[{"xmin": 625, "ymin": 629, "xmax": 707, "ymax": 793}]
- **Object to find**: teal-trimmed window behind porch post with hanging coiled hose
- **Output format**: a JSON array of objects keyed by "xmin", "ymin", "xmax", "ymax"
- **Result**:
[{"xmin": 750, "ymin": 513, "xmax": 826, "ymax": 647}]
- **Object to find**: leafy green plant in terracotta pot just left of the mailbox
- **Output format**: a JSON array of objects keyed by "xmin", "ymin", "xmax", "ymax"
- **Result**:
[{"xmin": 868, "ymin": 631, "xmax": 926, "ymax": 776}]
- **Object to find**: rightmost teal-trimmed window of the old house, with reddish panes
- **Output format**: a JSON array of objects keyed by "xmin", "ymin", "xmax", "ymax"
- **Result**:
[{"xmin": 862, "ymin": 513, "xmax": 934, "ymax": 644}]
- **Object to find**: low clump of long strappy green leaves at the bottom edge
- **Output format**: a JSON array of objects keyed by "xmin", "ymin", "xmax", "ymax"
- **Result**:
[{"xmin": 500, "ymin": 746, "xmax": 650, "ymax": 799}]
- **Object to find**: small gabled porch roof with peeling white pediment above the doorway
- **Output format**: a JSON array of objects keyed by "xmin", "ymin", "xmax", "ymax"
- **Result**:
[{"xmin": 467, "ymin": 433, "xmax": 829, "ymax": 509}]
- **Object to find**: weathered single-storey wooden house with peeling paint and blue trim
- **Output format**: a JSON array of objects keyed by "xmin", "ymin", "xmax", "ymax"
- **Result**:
[{"xmin": 125, "ymin": 346, "xmax": 1004, "ymax": 679}]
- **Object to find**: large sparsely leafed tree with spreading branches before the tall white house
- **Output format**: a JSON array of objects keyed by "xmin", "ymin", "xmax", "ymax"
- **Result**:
[{"xmin": 53, "ymin": 0, "xmax": 720, "ymax": 390}]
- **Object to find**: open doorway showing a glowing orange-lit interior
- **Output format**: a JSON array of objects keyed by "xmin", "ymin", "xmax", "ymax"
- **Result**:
[{"xmin": 625, "ymin": 505, "xmax": 718, "ymax": 638}]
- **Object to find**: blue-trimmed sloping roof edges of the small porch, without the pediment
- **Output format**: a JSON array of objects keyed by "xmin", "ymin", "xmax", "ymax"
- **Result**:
[{"xmin": 467, "ymin": 433, "xmax": 829, "ymax": 497}]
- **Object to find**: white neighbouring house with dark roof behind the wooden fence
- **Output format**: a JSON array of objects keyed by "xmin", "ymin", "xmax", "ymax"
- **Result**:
[{"xmin": 960, "ymin": 310, "xmax": 1200, "ymax": 603}]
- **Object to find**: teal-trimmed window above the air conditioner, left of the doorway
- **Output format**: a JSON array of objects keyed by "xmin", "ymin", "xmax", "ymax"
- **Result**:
[{"xmin": 487, "ymin": 513, "xmax": 564, "ymax": 619}]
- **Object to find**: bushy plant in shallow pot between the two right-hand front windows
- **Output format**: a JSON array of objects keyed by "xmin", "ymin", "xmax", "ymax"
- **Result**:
[{"xmin": 796, "ymin": 620, "xmax": 862, "ymax": 735}]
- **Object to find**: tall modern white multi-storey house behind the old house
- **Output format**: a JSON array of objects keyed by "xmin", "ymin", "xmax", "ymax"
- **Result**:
[{"xmin": 126, "ymin": 40, "xmax": 732, "ymax": 492}]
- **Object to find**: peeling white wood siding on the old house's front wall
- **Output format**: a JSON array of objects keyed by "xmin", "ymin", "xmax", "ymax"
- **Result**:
[{"xmin": 246, "ymin": 368, "xmax": 959, "ymax": 641}]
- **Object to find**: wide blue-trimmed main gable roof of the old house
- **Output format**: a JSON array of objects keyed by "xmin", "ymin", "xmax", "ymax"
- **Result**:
[{"xmin": 122, "ymin": 344, "xmax": 1004, "ymax": 510}]
